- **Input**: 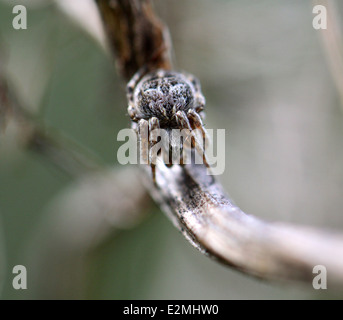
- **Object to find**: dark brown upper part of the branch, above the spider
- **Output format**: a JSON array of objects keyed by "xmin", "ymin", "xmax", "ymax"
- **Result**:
[{"xmin": 97, "ymin": 0, "xmax": 171, "ymax": 81}]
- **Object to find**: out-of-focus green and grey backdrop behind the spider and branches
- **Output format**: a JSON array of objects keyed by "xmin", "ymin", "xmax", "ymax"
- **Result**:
[{"xmin": 0, "ymin": 0, "xmax": 343, "ymax": 299}]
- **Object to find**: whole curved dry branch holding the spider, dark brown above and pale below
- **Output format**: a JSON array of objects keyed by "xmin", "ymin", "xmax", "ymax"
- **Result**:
[{"xmin": 97, "ymin": 0, "xmax": 343, "ymax": 285}]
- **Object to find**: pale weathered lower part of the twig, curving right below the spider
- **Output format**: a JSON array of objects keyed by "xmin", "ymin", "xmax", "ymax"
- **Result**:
[{"xmin": 146, "ymin": 163, "xmax": 343, "ymax": 285}]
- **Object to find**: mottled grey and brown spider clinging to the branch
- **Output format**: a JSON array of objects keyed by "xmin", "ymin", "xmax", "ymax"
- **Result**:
[{"xmin": 127, "ymin": 69, "xmax": 209, "ymax": 184}]
